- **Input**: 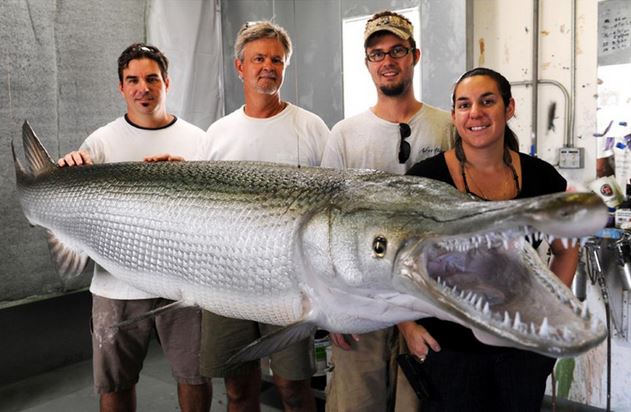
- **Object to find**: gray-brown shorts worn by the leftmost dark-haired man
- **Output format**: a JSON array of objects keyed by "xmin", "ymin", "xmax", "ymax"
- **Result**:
[{"xmin": 92, "ymin": 294, "xmax": 209, "ymax": 394}]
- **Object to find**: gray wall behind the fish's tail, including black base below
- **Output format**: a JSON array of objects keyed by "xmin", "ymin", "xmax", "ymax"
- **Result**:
[{"xmin": 0, "ymin": 0, "xmax": 145, "ymax": 392}]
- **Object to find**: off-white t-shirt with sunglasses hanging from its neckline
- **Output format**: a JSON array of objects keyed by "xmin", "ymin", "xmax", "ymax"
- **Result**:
[{"xmin": 322, "ymin": 103, "xmax": 454, "ymax": 174}]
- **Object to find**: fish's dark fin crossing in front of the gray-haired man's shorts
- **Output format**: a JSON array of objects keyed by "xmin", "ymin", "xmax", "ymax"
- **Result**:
[{"xmin": 226, "ymin": 321, "xmax": 317, "ymax": 365}]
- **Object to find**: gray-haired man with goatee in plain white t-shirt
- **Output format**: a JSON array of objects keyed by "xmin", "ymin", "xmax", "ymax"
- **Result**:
[{"xmin": 202, "ymin": 21, "xmax": 329, "ymax": 411}]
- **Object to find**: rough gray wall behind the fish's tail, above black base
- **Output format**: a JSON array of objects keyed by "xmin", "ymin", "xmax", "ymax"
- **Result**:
[{"xmin": 0, "ymin": 0, "xmax": 145, "ymax": 307}]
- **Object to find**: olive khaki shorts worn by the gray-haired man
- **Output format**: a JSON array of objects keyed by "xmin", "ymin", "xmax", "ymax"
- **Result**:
[{"xmin": 201, "ymin": 310, "xmax": 315, "ymax": 380}]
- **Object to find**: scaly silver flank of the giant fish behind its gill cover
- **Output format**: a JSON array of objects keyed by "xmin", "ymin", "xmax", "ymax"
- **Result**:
[{"xmin": 24, "ymin": 162, "xmax": 334, "ymax": 323}]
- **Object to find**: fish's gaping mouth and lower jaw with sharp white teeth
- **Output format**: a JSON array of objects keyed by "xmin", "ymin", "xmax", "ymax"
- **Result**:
[{"xmin": 400, "ymin": 226, "xmax": 605, "ymax": 356}]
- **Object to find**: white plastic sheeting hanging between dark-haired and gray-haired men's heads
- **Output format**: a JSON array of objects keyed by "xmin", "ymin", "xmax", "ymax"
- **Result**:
[{"xmin": 147, "ymin": 0, "xmax": 224, "ymax": 130}]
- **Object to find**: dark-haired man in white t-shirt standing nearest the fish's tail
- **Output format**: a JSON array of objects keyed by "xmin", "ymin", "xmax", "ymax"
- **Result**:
[{"xmin": 58, "ymin": 43, "xmax": 212, "ymax": 412}]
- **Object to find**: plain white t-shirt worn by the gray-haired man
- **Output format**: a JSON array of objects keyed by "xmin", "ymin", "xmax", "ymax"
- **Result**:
[{"xmin": 204, "ymin": 103, "xmax": 329, "ymax": 166}]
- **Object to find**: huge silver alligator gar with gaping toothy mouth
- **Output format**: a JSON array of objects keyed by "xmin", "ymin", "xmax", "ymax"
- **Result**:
[{"xmin": 13, "ymin": 123, "xmax": 607, "ymax": 359}]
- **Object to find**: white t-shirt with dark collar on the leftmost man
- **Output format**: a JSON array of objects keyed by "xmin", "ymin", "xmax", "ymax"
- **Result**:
[{"xmin": 80, "ymin": 117, "xmax": 205, "ymax": 300}]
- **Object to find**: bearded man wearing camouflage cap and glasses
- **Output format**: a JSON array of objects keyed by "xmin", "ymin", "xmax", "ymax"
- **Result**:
[{"xmin": 322, "ymin": 11, "xmax": 454, "ymax": 412}]
